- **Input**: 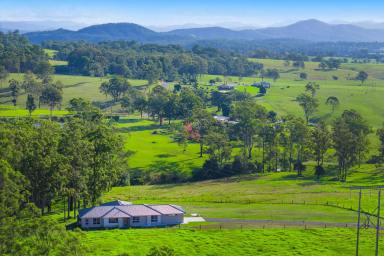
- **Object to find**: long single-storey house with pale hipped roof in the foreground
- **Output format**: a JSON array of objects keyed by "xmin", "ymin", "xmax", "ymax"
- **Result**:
[{"xmin": 79, "ymin": 201, "xmax": 185, "ymax": 229}]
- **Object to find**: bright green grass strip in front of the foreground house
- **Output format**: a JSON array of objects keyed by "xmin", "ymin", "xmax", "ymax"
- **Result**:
[{"xmin": 81, "ymin": 228, "xmax": 384, "ymax": 256}]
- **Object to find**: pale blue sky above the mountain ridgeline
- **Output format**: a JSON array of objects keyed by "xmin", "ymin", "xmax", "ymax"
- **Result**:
[{"xmin": 0, "ymin": 0, "xmax": 384, "ymax": 26}]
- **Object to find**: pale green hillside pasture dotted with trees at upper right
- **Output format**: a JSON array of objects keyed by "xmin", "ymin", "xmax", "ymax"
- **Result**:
[{"xmin": 200, "ymin": 59, "xmax": 384, "ymax": 128}]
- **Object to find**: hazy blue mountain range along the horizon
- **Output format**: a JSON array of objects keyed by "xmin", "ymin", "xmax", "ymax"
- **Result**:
[{"xmin": 25, "ymin": 20, "xmax": 384, "ymax": 44}]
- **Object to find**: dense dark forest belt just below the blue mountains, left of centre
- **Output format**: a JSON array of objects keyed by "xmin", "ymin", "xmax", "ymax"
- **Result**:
[{"xmin": 43, "ymin": 41, "xmax": 263, "ymax": 82}]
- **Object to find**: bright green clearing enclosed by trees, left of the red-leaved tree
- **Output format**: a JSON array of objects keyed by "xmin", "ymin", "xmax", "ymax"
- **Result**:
[{"xmin": 116, "ymin": 116, "xmax": 204, "ymax": 173}]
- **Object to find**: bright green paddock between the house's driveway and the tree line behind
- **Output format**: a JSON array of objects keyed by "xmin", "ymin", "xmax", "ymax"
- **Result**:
[{"xmin": 103, "ymin": 166, "xmax": 384, "ymax": 222}]
